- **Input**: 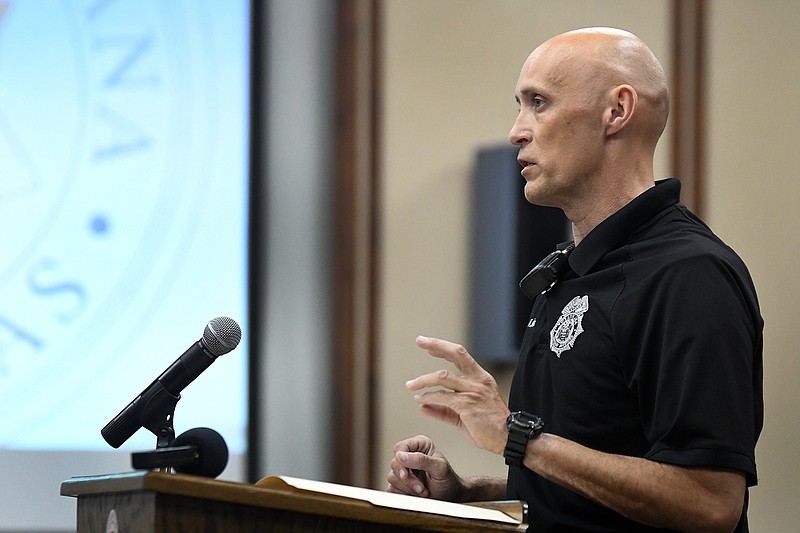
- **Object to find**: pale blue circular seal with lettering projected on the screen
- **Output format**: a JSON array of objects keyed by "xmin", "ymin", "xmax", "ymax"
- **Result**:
[{"xmin": 0, "ymin": 1, "xmax": 216, "ymax": 447}]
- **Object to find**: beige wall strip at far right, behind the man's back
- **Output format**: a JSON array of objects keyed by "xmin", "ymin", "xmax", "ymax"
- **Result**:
[{"xmin": 708, "ymin": 0, "xmax": 800, "ymax": 532}]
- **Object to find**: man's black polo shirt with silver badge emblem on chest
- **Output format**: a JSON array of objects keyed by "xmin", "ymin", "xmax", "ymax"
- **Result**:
[{"xmin": 508, "ymin": 179, "xmax": 763, "ymax": 532}]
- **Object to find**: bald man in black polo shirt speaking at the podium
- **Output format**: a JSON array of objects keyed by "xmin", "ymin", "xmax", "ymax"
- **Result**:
[{"xmin": 388, "ymin": 28, "xmax": 763, "ymax": 532}]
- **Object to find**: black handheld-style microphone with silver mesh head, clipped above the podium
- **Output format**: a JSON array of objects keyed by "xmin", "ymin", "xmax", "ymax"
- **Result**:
[{"xmin": 100, "ymin": 317, "xmax": 242, "ymax": 448}]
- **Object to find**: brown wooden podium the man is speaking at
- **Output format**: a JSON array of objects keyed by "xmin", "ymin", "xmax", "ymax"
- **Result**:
[{"xmin": 61, "ymin": 472, "xmax": 527, "ymax": 533}]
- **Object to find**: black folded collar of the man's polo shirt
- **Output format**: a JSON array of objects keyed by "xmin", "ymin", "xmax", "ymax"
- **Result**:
[{"xmin": 569, "ymin": 178, "xmax": 681, "ymax": 276}]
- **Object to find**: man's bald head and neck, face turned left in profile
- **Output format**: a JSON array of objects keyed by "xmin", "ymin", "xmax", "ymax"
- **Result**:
[{"xmin": 509, "ymin": 28, "xmax": 669, "ymax": 218}]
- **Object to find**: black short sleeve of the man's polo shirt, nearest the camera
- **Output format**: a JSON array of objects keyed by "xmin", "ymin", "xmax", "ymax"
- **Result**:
[{"xmin": 615, "ymin": 248, "xmax": 763, "ymax": 485}]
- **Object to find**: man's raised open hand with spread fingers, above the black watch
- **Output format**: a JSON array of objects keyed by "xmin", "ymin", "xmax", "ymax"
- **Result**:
[{"xmin": 406, "ymin": 337, "xmax": 509, "ymax": 454}]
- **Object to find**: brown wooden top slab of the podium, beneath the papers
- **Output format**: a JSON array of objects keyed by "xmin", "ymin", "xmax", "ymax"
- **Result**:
[{"xmin": 61, "ymin": 472, "xmax": 528, "ymax": 533}]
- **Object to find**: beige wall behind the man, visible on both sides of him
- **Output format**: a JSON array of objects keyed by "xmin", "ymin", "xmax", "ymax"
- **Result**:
[{"xmin": 375, "ymin": 0, "xmax": 800, "ymax": 531}]
